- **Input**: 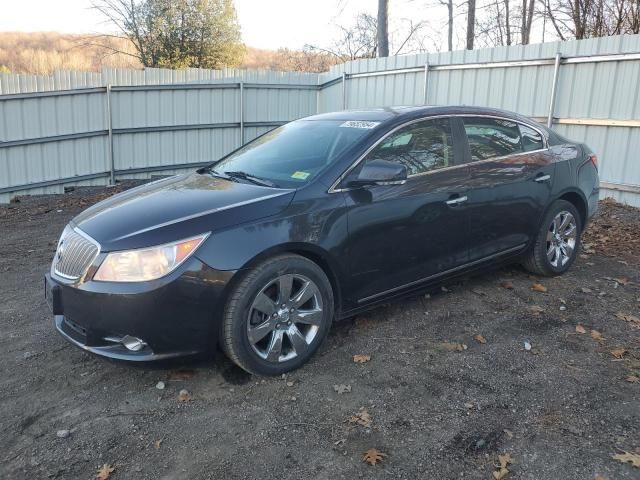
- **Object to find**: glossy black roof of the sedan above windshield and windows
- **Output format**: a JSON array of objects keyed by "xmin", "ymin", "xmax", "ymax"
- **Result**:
[{"xmin": 302, "ymin": 105, "xmax": 536, "ymax": 128}]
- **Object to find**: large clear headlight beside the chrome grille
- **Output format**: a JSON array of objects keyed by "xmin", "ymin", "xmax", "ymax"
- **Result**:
[{"xmin": 93, "ymin": 233, "xmax": 209, "ymax": 282}]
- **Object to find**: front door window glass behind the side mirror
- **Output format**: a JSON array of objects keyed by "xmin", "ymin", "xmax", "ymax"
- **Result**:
[{"xmin": 365, "ymin": 118, "xmax": 454, "ymax": 176}]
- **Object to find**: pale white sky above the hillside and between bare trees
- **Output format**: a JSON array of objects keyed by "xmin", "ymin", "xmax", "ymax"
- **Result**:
[{"xmin": 0, "ymin": 0, "xmax": 552, "ymax": 54}]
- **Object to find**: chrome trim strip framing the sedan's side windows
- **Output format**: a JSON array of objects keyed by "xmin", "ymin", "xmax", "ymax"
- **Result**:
[{"xmin": 327, "ymin": 113, "xmax": 549, "ymax": 193}]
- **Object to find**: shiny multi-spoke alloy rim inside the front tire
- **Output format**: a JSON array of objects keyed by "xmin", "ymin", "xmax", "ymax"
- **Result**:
[{"xmin": 247, "ymin": 274, "xmax": 324, "ymax": 363}]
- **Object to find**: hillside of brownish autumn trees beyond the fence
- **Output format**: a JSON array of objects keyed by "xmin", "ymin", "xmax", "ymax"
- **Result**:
[{"xmin": 0, "ymin": 32, "xmax": 336, "ymax": 74}]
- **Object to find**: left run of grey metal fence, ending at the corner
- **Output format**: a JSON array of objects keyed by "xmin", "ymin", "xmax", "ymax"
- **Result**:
[{"xmin": 0, "ymin": 69, "xmax": 319, "ymax": 202}]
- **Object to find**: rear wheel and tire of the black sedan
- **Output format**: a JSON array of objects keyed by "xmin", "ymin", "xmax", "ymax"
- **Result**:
[{"xmin": 522, "ymin": 200, "xmax": 582, "ymax": 277}]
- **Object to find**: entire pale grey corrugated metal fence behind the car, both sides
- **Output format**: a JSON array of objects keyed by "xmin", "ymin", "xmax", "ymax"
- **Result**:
[{"xmin": 0, "ymin": 35, "xmax": 640, "ymax": 205}]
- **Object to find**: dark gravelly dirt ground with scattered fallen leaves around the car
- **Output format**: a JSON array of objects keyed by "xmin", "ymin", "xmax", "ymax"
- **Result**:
[{"xmin": 0, "ymin": 185, "xmax": 640, "ymax": 480}]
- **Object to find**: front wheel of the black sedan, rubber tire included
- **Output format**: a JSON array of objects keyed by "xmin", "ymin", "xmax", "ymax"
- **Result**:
[{"xmin": 221, "ymin": 254, "xmax": 334, "ymax": 376}]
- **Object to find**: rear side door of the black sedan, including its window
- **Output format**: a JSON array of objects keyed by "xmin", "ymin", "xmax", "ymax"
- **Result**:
[{"xmin": 462, "ymin": 116, "xmax": 555, "ymax": 262}]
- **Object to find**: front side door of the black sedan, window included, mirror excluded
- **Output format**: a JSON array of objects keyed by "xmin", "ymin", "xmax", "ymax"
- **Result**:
[{"xmin": 344, "ymin": 118, "xmax": 469, "ymax": 303}]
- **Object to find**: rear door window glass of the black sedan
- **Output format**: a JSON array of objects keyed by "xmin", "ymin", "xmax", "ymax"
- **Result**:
[{"xmin": 463, "ymin": 117, "xmax": 524, "ymax": 162}]
